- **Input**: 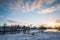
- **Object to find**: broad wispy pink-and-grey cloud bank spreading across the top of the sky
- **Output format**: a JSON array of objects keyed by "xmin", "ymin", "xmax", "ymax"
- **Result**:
[{"xmin": 0, "ymin": 0, "xmax": 56, "ymax": 15}]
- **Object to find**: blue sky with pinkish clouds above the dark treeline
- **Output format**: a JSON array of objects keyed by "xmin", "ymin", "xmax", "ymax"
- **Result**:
[{"xmin": 0, "ymin": 0, "xmax": 60, "ymax": 25}]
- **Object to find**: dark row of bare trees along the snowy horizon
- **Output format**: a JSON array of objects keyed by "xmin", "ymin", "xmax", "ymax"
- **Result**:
[{"xmin": 0, "ymin": 23, "xmax": 60, "ymax": 34}]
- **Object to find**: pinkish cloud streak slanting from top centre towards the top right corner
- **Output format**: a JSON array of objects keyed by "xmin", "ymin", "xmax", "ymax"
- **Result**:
[{"xmin": 31, "ymin": 0, "xmax": 56, "ymax": 11}]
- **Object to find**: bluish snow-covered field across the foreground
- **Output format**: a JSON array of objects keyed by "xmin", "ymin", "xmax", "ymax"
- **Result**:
[{"xmin": 0, "ymin": 32, "xmax": 60, "ymax": 40}]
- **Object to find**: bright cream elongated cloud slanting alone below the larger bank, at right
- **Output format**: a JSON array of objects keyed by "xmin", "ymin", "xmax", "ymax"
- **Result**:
[{"xmin": 38, "ymin": 4, "xmax": 60, "ymax": 14}]
